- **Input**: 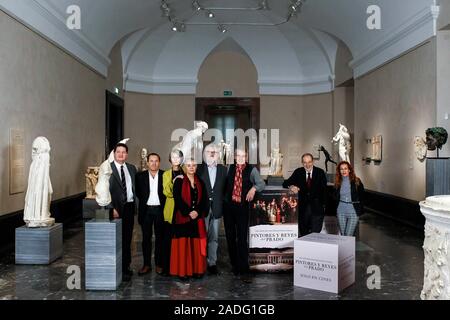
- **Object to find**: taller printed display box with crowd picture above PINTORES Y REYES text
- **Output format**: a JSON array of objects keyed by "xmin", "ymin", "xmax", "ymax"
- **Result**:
[{"xmin": 249, "ymin": 186, "xmax": 298, "ymax": 272}]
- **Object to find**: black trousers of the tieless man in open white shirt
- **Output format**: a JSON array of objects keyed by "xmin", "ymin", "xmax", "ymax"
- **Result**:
[{"xmin": 141, "ymin": 206, "xmax": 164, "ymax": 267}]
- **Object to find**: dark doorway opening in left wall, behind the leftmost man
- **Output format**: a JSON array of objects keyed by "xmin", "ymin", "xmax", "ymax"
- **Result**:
[{"xmin": 105, "ymin": 91, "xmax": 125, "ymax": 157}]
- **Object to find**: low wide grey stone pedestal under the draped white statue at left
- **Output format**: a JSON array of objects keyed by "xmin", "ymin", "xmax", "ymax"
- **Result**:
[{"xmin": 16, "ymin": 223, "xmax": 63, "ymax": 264}]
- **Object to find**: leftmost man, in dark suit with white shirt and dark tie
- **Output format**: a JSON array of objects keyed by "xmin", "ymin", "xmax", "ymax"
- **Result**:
[{"xmin": 109, "ymin": 143, "xmax": 137, "ymax": 281}]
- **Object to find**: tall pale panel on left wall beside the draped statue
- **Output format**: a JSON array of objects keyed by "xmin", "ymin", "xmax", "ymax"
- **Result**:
[{"xmin": 9, "ymin": 129, "xmax": 25, "ymax": 195}]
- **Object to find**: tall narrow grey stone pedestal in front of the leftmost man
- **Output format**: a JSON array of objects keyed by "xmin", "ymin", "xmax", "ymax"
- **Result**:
[{"xmin": 84, "ymin": 220, "xmax": 122, "ymax": 290}]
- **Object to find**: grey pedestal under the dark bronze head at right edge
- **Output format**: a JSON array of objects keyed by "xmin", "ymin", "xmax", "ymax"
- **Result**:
[{"xmin": 426, "ymin": 158, "xmax": 450, "ymax": 197}]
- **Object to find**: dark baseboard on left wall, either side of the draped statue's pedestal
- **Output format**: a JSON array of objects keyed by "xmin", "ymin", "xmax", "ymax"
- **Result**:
[{"xmin": 0, "ymin": 193, "xmax": 86, "ymax": 248}]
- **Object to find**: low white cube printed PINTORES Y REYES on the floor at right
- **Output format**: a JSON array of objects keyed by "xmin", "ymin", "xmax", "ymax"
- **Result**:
[{"xmin": 294, "ymin": 233, "xmax": 355, "ymax": 293}]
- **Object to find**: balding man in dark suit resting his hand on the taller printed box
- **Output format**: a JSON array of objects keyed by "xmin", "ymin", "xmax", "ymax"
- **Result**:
[{"xmin": 283, "ymin": 153, "xmax": 327, "ymax": 237}]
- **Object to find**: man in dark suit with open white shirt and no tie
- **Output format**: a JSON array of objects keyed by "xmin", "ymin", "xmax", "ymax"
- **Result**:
[{"xmin": 136, "ymin": 153, "xmax": 170, "ymax": 275}]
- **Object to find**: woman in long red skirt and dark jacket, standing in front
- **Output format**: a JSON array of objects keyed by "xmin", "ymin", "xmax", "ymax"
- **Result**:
[{"xmin": 170, "ymin": 159, "xmax": 209, "ymax": 280}]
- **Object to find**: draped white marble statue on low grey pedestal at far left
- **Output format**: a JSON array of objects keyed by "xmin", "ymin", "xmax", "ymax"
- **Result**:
[{"xmin": 23, "ymin": 137, "xmax": 55, "ymax": 228}]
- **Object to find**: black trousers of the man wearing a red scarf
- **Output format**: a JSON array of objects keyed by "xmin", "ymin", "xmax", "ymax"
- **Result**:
[{"xmin": 223, "ymin": 202, "xmax": 249, "ymax": 273}]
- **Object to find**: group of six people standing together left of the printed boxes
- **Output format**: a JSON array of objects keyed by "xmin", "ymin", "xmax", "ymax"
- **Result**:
[{"xmin": 110, "ymin": 144, "xmax": 265, "ymax": 282}]
